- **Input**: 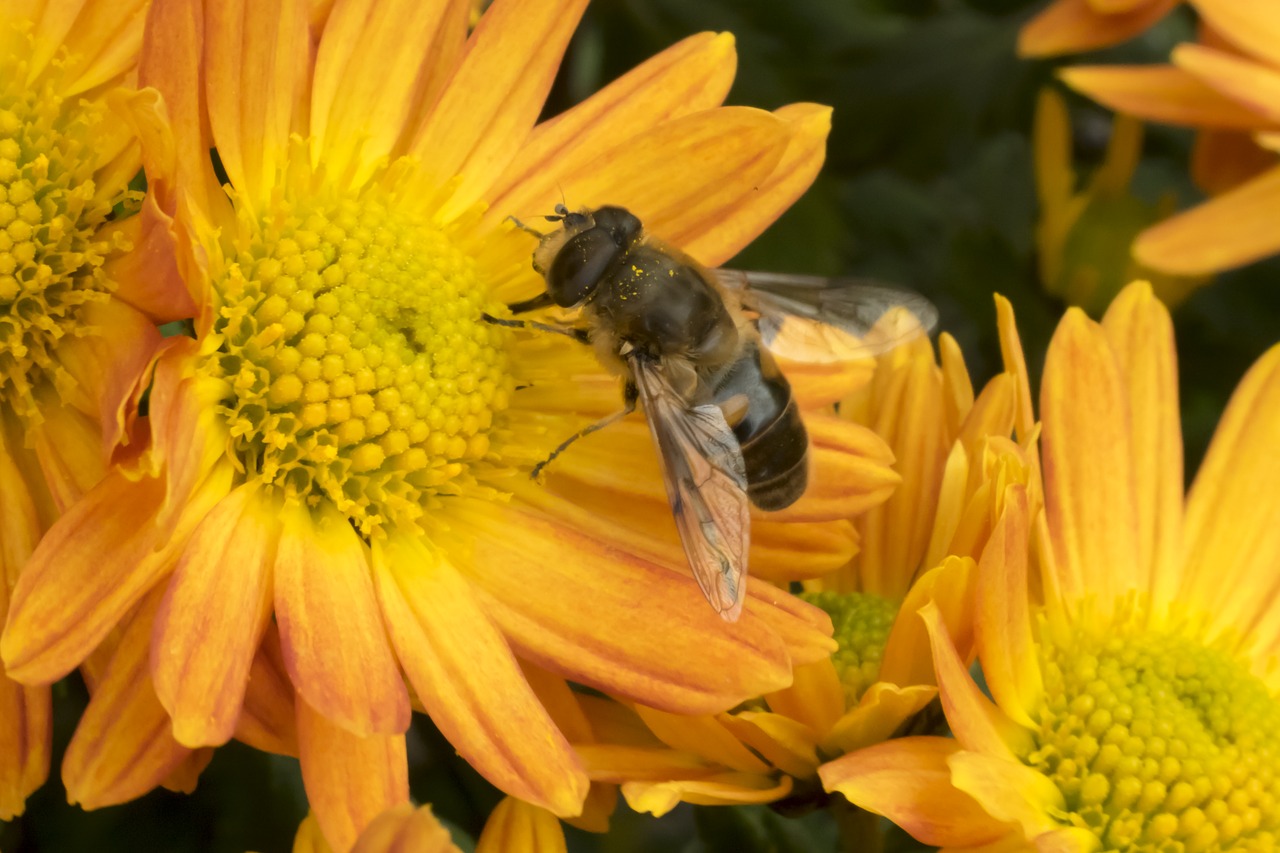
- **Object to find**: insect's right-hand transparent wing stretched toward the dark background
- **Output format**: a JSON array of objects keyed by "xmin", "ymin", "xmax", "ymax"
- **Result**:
[{"xmin": 716, "ymin": 269, "xmax": 938, "ymax": 362}]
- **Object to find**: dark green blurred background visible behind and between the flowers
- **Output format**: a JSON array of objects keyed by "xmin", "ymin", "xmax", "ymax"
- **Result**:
[{"xmin": 0, "ymin": 0, "xmax": 1280, "ymax": 853}]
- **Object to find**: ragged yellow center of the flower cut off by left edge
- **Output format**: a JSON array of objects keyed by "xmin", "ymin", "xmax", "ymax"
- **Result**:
[{"xmin": 0, "ymin": 34, "xmax": 128, "ymax": 423}]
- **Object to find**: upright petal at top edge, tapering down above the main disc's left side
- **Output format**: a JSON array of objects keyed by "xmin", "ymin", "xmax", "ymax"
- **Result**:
[{"xmin": 205, "ymin": 0, "xmax": 311, "ymax": 210}]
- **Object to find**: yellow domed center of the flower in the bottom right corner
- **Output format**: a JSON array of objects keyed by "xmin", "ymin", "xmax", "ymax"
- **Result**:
[{"xmin": 1024, "ymin": 628, "xmax": 1280, "ymax": 853}]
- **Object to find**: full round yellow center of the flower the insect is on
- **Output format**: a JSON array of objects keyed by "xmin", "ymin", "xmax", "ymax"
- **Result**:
[{"xmin": 205, "ymin": 191, "xmax": 513, "ymax": 535}]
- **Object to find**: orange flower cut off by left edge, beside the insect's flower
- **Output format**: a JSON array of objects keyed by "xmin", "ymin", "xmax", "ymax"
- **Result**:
[{"xmin": 0, "ymin": 0, "xmax": 192, "ymax": 820}]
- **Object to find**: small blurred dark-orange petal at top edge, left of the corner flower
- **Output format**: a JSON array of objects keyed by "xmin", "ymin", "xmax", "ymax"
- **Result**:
[{"xmin": 1018, "ymin": 0, "xmax": 1179, "ymax": 58}]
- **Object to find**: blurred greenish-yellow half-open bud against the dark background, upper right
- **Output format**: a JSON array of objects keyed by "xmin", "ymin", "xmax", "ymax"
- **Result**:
[{"xmin": 1034, "ymin": 88, "xmax": 1210, "ymax": 314}]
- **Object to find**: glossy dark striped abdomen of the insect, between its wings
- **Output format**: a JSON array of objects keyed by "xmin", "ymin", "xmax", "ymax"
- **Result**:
[{"xmin": 714, "ymin": 343, "xmax": 809, "ymax": 511}]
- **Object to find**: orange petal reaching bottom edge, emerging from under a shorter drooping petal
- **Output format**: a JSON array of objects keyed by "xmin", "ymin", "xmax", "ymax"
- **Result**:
[{"xmin": 297, "ymin": 701, "xmax": 408, "ymax": 850}]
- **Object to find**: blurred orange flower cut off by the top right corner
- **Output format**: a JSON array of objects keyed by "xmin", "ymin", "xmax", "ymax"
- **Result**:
[{"xmin": 1062, "ymin": 0, "xmax": 1280, "ymax": 275}]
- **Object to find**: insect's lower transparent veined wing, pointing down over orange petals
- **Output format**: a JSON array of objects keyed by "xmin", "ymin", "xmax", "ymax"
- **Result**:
[{"xmin": 628, "ymin": 355, "xmax": 750, "ymax": 622}]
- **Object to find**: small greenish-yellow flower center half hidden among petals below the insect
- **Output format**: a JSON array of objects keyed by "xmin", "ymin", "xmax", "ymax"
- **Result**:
[{"xmin": 800, "ymin": 592, "xmax": 899, "ymax": 708}]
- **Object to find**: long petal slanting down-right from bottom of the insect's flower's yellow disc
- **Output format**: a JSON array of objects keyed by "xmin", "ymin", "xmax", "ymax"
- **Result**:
[{"xmin": 374, "ymin": 535, "xmax": 588, "ymax": 816}]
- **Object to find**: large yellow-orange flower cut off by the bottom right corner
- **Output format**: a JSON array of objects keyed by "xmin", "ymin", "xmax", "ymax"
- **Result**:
[{"xmin": 823, "ymin": 283, "xmax": 1280, "ymax": 852}]
